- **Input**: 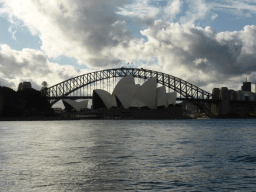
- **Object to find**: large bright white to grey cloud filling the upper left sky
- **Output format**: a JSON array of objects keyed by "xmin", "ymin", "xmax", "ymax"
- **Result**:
[{"xmin": 0, "ymin": 0, "xmax": 130, "ymax": 68}]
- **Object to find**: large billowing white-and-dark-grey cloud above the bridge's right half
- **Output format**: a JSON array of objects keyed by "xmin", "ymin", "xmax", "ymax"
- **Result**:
[{"xmin": 108, "ymin": 20, "xmax": 256, "ymax": 91}]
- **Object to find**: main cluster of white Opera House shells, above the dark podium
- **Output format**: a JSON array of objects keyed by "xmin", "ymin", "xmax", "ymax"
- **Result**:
[{"xmin": 92, "ymin": 75, "xmax": 177, "ymax": 109}]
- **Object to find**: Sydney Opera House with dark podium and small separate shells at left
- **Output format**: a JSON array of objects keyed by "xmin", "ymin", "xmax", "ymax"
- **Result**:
[{"xmin": 63, "ymin": 75, "xmax": 183, "ymax": 119}]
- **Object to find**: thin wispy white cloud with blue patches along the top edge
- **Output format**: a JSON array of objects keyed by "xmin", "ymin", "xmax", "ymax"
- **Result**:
[{"xmin": 116, "ymin": 0, "xmax": 219, "ymax": 26}]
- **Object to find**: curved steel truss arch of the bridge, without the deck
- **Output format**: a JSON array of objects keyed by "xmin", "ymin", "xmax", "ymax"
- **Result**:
[{"xmin": 42, "ymin": 67, "xmax": 215, "ymax": 118}]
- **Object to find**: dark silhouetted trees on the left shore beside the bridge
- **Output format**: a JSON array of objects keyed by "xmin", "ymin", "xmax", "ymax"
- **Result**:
[{"xmin": 0, "ymin": 87, "xmax": 55, "ymax": 117}]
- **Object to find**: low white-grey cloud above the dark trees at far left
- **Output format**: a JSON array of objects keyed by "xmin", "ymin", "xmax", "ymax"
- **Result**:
[{"xmin": 0, "ymin": 44, "xmax": 91, "ymax": 90}]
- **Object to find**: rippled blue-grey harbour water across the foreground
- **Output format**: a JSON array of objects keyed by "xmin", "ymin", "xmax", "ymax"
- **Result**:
[{"xmin": 0, "ymin": 120, "xmax": 256, "ymax": 191}]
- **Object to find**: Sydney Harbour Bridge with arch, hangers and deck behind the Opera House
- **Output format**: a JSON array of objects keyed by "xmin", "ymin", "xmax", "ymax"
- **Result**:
[{"xmin": 42, "ymin": 67, "xmax": 220, "ymax": 118}]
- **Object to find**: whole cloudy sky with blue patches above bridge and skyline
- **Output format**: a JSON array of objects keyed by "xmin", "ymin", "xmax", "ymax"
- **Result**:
[{"xmin": 0, "ymin": 0, "xmax": 256, "ymax": 106}]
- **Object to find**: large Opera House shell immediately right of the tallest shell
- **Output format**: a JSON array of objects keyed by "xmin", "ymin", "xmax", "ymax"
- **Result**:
[{"xmin": 134, "ymin": 77, "xmax": 157, "ymax": 109}]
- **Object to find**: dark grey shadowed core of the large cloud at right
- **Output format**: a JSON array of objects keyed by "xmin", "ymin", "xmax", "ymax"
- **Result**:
[{"xmin": 183, "ymin": 28, "xmax": 242, "ymax": 75}]
